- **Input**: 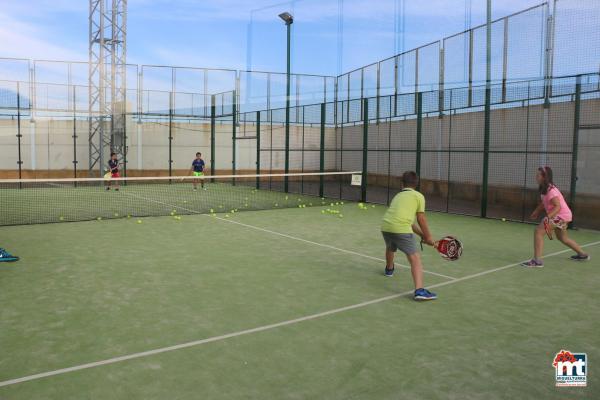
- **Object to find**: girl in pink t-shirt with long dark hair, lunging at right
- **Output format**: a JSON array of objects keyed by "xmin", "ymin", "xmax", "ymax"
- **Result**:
[{"xmin": 523, "ymin": 167, "xmax": 590, "ymax": 268}]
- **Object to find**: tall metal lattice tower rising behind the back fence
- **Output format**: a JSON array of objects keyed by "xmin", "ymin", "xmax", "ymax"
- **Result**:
[{"xmin": 89, "ymin": 0, "xmax": 127, "ymax": 176}]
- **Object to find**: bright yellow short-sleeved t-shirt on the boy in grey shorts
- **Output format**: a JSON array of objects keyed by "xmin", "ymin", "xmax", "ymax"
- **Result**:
[{"xmin": 381, "ymin": 189, "xmax": 425, "ymax": 233}]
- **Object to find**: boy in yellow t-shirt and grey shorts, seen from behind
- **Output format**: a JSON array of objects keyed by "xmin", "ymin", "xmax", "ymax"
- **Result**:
[{"xmin": 381, "ymin": 171, "xmax": 437, "ymax": 301}]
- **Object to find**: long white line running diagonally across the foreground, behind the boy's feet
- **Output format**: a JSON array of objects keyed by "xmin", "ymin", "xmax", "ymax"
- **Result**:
[{"xmin": 0, "ymin": 241, "xmax": 600, "ymax": 387}]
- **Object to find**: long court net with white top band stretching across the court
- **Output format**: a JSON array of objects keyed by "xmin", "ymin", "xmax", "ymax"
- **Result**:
[{"xmin": 0, "ymin": 172, "xmax": 360, "ymax": 226}]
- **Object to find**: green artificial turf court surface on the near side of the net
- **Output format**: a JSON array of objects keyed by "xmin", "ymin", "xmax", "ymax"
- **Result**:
[{"xmin": 0, "ymin": 186, "xmax": 600, "ymax": 399}]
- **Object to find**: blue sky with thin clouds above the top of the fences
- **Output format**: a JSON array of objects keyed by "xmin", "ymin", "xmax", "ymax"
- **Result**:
[{"xmin": 0, "ymin": 0, "xmax": 552, "ymax": 75}]
